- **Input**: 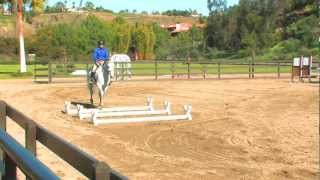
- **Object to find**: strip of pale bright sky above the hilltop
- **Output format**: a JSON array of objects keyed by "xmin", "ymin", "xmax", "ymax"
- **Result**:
[{"xmin": 47, "ymin": 0, "xmax": 239, "ymax": 15}]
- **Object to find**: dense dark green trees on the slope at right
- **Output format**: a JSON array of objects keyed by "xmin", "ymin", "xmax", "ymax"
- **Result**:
[{"xmin": 205, "ymin": 0, "xmax": 320, "ymax": 60}]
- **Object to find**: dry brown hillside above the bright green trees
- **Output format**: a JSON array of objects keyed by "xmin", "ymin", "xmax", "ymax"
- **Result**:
[{"xmin": 0, "ymin": 12, "xmax": 199, "ymax": 37}]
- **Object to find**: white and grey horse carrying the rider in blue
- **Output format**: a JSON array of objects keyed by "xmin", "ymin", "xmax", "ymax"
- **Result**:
[{"xmin": 88, "ymin": 62, "xmax": 111, "ymax": 107}]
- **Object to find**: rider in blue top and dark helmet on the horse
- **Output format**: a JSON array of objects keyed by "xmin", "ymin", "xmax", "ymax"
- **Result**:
[{"xmin": 91, "ymin": 41, "xmax": 109, "ymax": 77}]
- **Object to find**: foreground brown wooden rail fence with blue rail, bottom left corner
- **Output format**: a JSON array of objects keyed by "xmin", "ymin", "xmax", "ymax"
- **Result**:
[{"xmin": 0, "ymin": 101, "xmax": 127, "ymax": 180}]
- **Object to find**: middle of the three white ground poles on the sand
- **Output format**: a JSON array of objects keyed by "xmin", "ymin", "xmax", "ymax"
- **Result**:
[{"xmin": 79, "ymin": 101, "xmax": 171, "ymax": 120}]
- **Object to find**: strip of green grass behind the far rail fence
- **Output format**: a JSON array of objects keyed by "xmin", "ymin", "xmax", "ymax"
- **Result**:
[{"xmin": 0, "ymin": 63, "xmax": 291, "ymax": 79}]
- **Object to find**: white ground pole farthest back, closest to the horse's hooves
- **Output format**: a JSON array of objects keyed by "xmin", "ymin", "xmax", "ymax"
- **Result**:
[{"xmin": 64, "ymin": 97, "xmax": 154, "ymax": 118}]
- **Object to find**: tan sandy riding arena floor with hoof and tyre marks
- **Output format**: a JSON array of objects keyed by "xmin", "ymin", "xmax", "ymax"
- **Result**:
[{"xmin": 0, "ymin": 79, "xmax": 319, "ymax": 180}]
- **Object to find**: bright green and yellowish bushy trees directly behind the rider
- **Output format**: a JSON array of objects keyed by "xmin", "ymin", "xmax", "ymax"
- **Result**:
[{"xmin": 26, "ymin": 15, "xmax": 155, "ymax": 61}]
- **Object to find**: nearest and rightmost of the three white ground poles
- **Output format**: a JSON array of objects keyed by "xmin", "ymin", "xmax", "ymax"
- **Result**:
[{"xmin": 92, "ymin": 105, "xmax": 192, "ymax": 126}]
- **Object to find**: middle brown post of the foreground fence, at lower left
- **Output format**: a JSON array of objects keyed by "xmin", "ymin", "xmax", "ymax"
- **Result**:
[{"xmin": 25, "ymin": 123, "xmax": 37, "ymax": 156}]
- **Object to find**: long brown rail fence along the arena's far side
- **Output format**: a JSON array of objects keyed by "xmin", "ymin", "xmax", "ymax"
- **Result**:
[{"xmin": 34, "ymin": 61, "xmax": 319, "ymax": 83}]
